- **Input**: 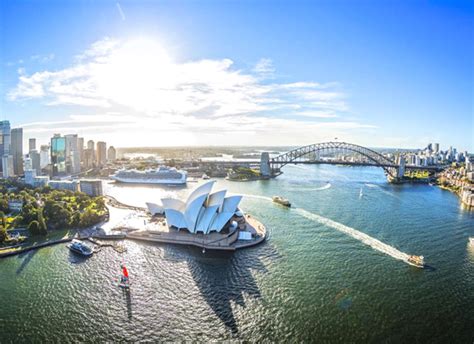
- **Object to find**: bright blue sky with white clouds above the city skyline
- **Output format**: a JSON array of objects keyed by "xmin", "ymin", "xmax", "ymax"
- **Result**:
[{"xmin": 0, "ymin": 0, "xmax": 474, "ymax": 152}]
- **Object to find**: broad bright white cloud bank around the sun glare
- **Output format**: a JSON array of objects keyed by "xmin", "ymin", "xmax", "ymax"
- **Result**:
[{"xmin": 8, "ymin": 38, "xmax": 372, "ymax": 145}]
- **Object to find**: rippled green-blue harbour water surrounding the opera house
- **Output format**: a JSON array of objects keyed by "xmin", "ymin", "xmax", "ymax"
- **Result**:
[{"xmin": 0, "ymin": 166, "xmax": 474, "ymax": 343}]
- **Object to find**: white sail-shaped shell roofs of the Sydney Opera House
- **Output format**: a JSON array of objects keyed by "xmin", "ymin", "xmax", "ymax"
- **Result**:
[{"xmin": 147, "ymin": 181, "xmax": 243, "ymax": 234}]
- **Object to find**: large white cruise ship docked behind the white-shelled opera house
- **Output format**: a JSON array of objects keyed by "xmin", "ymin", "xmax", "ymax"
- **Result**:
[{"xmin": 110, "ymin": 166, "xmax": 188, "ymax": 185}]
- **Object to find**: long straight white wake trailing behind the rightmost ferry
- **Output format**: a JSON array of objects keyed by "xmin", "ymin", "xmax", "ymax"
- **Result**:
[{"xmin": 295, "ymin": 208, "xmax": 409, "ymax": 262}]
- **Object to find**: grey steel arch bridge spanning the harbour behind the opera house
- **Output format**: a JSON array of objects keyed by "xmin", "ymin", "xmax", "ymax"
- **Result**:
[{"xmin": 268, "ymin": 142, "xmax": 399, "ymax": 178}]
